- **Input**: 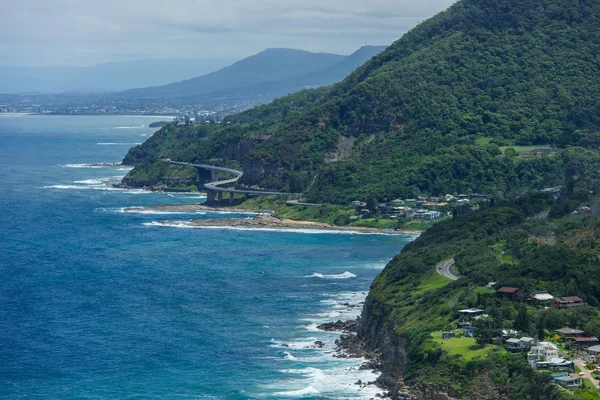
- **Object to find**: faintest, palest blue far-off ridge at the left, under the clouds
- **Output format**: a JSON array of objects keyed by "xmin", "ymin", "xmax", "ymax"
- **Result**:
[{"xmin": 0, "ymin": 59, "xmax": 233, "ymax": 93}]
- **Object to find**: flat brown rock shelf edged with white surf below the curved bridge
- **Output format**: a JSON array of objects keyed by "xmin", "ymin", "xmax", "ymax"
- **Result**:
[{"xmin": 131, "ymin": 204, "xmax": 421, "ymax": 235}]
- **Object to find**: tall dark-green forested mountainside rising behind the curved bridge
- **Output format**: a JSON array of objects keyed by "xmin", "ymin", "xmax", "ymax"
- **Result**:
[{"xmin": 120, "ymin": 0, "xmax": 600, "ymax": 202}]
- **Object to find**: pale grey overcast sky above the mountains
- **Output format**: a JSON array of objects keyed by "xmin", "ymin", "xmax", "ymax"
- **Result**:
[{"xmin": 0, "ymin": 0, "xmax": 454, "ymax": 66}]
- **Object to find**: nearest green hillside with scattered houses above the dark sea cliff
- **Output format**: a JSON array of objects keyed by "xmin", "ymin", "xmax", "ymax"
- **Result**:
[{"xmin": 361, "ymin": 193, "xmax": 600, "ymax": 400}]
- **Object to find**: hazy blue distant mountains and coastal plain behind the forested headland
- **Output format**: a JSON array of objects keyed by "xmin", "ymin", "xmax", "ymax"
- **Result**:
[{"xmin": 0, "ymin": 46, "xmax": 386, "ymax": 118}]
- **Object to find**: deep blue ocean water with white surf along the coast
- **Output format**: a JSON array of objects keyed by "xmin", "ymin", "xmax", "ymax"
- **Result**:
[{"xmin": 0, "ymin": 115, "xmax": 412, "ymax": 399}]
